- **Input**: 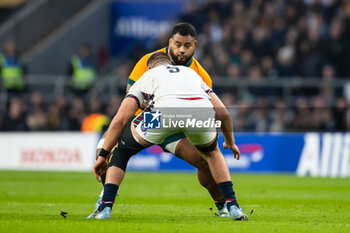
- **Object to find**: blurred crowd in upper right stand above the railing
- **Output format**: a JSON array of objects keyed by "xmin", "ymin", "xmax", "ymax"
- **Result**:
[{"xmin": 182, "ymin": 0, "xmax": 350, "ymax": 79}]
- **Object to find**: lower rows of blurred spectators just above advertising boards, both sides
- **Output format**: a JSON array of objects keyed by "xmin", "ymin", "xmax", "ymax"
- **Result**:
[{"xmin": 0, "ymin": 89, "xmax": 350, "ymax": 132}]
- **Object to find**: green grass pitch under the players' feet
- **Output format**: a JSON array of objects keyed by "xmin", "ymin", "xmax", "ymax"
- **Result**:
[{"xmin": 0, "ymin": 171, "xmax": 350, "ymax": 233}]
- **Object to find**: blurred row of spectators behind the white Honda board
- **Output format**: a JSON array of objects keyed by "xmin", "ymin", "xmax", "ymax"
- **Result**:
[{"xmin": 0, "ymin": 92, "xmax": 121, "ymax": 131}]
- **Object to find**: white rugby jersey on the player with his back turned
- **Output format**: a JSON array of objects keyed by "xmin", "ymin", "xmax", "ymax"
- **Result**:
[{"xmin": 127, "ymin": 65, "xmax": 212, "ymax": 105}]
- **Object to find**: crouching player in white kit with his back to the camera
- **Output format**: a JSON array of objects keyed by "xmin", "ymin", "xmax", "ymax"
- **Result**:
[{"xmin": 90, "ymin": 52, "xmax": 248, "ymax": 220}]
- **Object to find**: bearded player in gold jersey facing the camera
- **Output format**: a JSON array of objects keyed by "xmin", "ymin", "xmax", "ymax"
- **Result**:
[{"xmin": 88, "ymin": 22, "xmax": 230, "ymax": 218}]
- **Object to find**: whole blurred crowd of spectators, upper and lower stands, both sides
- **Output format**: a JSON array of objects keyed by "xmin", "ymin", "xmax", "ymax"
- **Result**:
[{"xmin": 0, "ymin": 0, "xmax": 350, "ymax": 132}]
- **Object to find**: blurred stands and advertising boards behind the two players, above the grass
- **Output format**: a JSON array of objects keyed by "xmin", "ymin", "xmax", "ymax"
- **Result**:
[{"xmin": 0, "ymin": 0, "xmax": 350, "ymax": 177}]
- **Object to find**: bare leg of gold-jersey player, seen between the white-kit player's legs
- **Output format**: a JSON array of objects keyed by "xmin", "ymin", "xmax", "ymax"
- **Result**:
[{"xmin": 175, "ymin": 138, "xmax": 224, "ymax": 201}]
